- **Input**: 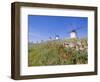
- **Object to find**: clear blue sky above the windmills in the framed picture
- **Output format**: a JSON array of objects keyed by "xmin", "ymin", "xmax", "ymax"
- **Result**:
[{"xmin": 28, "ymin": 15, "xmax": 88, "ymax": 42}]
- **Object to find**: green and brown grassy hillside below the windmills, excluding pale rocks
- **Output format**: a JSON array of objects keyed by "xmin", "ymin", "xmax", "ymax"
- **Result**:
[{"xmin": 28, "ymin": 39, "xmax": 88, "ymax": 66}]
